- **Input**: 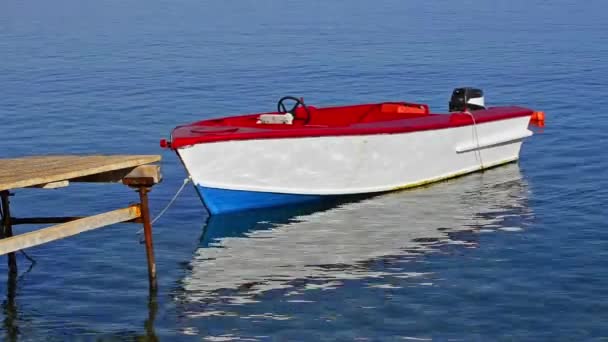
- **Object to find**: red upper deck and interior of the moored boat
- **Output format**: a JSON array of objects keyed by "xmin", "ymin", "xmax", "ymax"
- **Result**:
[{"xmin": 171, "ymin": 102, "xmax": 533, "ymax": 149}]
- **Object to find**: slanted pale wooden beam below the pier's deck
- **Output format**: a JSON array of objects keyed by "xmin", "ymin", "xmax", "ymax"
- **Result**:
[{"xmin": 0, "ymin": 205, "xmax": 141, "ymax": 255}]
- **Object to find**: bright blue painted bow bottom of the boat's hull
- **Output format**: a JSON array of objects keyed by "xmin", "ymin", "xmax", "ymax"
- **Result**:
[{"xmin": 196, "ymin": 185, "xmax": 328, "ymax": 215}]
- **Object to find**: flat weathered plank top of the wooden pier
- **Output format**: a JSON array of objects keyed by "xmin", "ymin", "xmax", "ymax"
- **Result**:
[{"xmin": 0, "ymin": 155, "xmax": 161, "ymax": 190}]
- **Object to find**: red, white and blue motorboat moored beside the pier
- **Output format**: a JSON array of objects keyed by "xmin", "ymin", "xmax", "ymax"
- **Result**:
[{"xmin": 161, "ymin": 88, "xmax": 538, "ymax": 214}]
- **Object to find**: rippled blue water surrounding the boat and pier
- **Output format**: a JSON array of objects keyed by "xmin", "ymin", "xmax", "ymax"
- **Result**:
[{"xmin": 0, "ymin": 0, "xmax": 608, "ymax": 341}]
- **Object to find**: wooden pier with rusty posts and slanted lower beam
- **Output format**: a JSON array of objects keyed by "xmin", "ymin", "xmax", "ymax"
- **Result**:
[{"xmin": 0, "ymin": 155, "xmax": 161, "ymax": 290}]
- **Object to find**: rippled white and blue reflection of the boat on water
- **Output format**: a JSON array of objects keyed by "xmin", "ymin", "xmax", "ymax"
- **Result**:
[{"xmin": 176, "ymin": 164, "xmax": 531, "ymax": 304}]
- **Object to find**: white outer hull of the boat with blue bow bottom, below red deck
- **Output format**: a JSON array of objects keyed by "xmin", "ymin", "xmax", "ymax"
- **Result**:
[{"xmin": 177, "ymin": 116, "xmax": 532, "ymax": 214}]
